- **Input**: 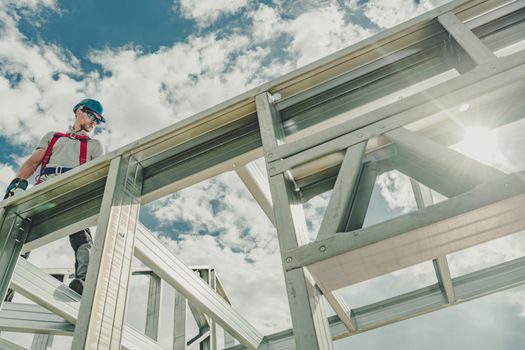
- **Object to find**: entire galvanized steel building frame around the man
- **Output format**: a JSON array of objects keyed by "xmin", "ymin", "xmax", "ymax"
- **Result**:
[{"xmin": 0, "ymin": 0, "xmax": 525, "ymax": 350}]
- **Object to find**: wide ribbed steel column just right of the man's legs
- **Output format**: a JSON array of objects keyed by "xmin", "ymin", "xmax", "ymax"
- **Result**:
[{"xmin": 72, "ymin": 156, "xmax": 142, "ymax": 350}]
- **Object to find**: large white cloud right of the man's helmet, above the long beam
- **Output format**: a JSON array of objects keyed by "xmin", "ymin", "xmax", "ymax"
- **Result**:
[{"xmin": 87, "ymin": 33, "xmax": 292, "ymax": 149}]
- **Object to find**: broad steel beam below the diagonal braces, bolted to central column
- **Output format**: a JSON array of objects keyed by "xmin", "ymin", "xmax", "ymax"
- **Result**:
[{"xmin": 284, "ymin": 172, "xmax": 525, "ymax": 292}]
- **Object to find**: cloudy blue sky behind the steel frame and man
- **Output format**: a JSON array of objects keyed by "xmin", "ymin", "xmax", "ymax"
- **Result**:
[{"xmin": 0, "ymin": 0, "xmax": 525, "ymax": 350}]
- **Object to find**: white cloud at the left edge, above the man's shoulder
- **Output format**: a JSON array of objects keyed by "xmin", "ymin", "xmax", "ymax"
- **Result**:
[{"xmin": 0, "ymin": 2, "xmax": 83, "ymax": 143}]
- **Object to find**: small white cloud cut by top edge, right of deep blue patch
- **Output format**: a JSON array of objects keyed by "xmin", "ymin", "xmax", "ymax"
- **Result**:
[{"xmin": 175, "ymin": 0, "xmax": 248, "ymax": 27}]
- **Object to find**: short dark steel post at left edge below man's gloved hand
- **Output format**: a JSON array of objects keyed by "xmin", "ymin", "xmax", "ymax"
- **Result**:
[{"xmin": 0, "ymin": 208, "xmax": 30, "ymax": 305}]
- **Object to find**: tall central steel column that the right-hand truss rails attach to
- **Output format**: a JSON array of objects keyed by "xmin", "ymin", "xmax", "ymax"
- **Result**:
[{"xmin": 256, "ymin": 93, "xmax": 333, "ymax": 350}]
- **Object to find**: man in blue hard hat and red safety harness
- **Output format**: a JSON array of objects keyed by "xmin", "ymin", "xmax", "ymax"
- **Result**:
[{"xmin": 4, "ymin": 99, "xmax": 105, "ymax": 301}]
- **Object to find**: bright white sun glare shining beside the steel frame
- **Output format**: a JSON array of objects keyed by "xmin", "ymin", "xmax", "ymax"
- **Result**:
[{"xmin": 454, "ymin": 127, "xmax": 502, "ymax": 165}]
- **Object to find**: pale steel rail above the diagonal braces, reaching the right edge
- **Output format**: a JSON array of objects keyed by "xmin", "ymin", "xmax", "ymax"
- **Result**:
[{"xmin": 267, "ymin": 53, "xmax": 525, "ymax": 176}]
